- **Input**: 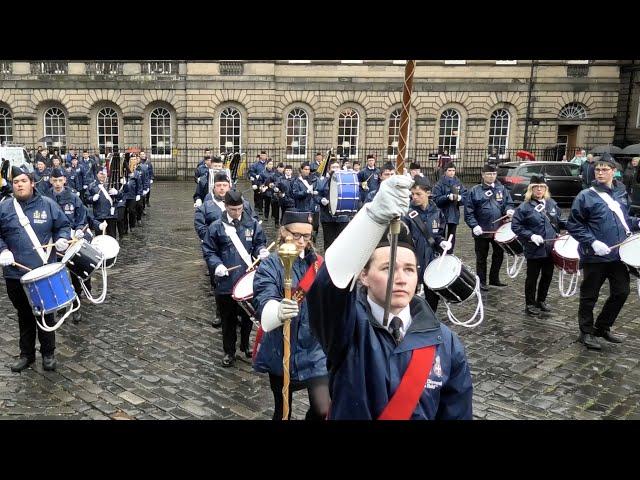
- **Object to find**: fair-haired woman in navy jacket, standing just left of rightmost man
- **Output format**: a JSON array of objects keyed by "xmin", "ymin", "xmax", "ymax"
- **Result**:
[{"xmin": 511, "ymin": 175, "xmax": 565, "ymax": 317}]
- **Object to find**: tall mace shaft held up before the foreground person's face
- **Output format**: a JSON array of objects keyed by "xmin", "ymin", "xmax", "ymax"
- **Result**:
[{"xmin": 382, "ymin": 60, "xmax": 416, "ymax": 327}]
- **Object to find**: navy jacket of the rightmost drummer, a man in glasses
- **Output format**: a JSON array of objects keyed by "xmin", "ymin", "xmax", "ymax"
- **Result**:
[{"xmin": 567, "ymin": 182, "xmax": 640, "ymax": 263}]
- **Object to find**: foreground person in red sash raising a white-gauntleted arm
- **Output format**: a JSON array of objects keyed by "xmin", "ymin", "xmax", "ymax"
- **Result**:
[{"xmin": 304, "ymin": 175, "xmax": 472, "ymax": 420}]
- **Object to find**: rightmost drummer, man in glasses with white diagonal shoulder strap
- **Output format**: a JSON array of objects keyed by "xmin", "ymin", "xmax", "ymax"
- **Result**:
[{"xmin": 567, "ymin": 154, "xmax": 640, "ymax": 350}]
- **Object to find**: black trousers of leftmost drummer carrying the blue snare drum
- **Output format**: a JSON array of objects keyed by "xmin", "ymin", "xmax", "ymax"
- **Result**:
[{"xmin": 5, "ymin": 278, "xmax": 56, "ymax": 358}]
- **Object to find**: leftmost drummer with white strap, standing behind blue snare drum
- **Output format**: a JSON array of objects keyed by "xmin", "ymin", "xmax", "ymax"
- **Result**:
[{"xmin": 0, "ymin": 167, "xmax": 71, "ymax": 372}]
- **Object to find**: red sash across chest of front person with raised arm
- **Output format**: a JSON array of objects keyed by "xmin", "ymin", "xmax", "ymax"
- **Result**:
[{"xmin": 378, "ymin": 345, "xmax": 436, "ymax": 420}]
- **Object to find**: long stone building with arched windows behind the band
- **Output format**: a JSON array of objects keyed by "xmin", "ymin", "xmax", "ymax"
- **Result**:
[{"xmin": 0, "ymin": 60, "xmax": 638, "ymax": 176}]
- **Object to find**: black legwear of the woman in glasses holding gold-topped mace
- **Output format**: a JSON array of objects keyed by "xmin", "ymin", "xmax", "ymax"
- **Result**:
[{"xmin": 269, "ymin": 374, "xmax": 330, "ymax": 420}]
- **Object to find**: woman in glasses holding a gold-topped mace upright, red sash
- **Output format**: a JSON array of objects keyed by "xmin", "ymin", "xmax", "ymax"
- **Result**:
[{"xmin": 253, "ymin": 210, "xmax": 329, "ymax": 420}]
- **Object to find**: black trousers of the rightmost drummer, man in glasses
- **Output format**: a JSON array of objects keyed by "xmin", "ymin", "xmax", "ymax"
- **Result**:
[{"xmin": 578, "ymin": 261, "xmax": 630, "ymax": 333}]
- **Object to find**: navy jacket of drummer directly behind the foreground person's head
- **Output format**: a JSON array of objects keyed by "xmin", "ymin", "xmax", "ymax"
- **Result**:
[{"xmin": 404, "ymin": 202, "xmax": 447, "ymax": 281}]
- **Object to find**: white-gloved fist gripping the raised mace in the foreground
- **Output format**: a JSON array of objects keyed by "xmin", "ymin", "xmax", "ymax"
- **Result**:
[{"xmin": 367, "ymin": 175, "xmax": 413, "ymax": 225}]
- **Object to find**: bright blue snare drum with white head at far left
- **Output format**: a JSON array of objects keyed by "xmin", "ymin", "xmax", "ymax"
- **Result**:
[{"xmin": 20, "ymin": 263, "xmax": 77, "ymax": 316}]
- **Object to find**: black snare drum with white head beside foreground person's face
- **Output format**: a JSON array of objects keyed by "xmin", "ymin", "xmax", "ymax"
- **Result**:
[{"xmin": 424, "ymin": 255, "xmax": 476, "ymax": 303}]
